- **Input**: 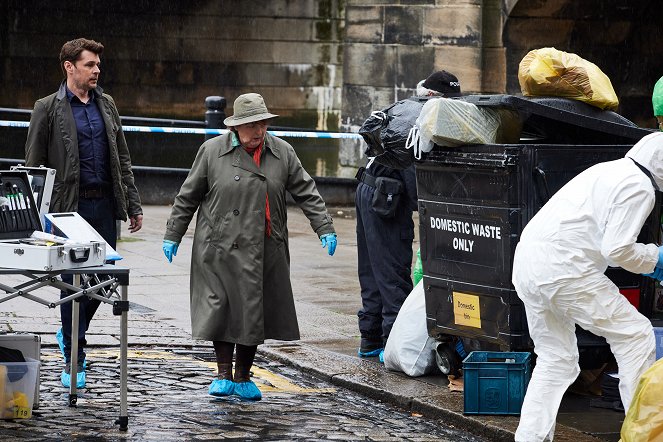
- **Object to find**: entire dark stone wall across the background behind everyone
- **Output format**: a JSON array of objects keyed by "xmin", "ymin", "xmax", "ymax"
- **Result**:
[{"xmin": 0, "ymin": 0, "xmax": 663, "ymax": 180}]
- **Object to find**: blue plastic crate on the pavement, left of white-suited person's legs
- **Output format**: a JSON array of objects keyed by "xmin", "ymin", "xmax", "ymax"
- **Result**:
[{"xmin": 463, "ymin": 351, "xmax": 532, "ymax": 415}]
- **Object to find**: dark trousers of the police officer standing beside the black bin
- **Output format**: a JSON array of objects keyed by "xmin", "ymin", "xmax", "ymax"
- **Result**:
[{"xmin": 355, "ymin": 182, "xmax": 414, "ymax": 344}]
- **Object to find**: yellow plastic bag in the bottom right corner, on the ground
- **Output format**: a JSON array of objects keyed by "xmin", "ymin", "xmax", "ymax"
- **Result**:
[{"xmin": 620, "ymin": 359, "xmax": 663, "ymax": 442}]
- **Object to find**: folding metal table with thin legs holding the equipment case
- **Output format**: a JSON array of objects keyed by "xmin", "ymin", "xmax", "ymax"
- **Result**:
[{"xmin": 0, "ymin": 264, "xmax": 129, "ymax": 431}]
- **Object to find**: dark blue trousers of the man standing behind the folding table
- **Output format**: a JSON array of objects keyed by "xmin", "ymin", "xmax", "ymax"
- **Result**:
[{"xmin": 60, "ymin": 198, "xmax": 117, "ymax": 362}]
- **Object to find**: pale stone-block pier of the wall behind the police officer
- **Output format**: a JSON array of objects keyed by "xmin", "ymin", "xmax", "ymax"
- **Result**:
[{"xmin": 339, "ymin": 0, "xmax": 490, "ymax": 175}]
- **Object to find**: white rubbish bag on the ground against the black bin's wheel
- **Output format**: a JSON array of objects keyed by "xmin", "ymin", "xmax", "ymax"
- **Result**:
[{"xmin": 384, "ymin": 280, "xmax": 437, "ymax": 376}]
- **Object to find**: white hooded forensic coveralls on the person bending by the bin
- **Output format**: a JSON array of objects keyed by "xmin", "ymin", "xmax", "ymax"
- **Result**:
[{"xmin": 512, "ymin": 132, "xmax": 663, "ymax": 442}]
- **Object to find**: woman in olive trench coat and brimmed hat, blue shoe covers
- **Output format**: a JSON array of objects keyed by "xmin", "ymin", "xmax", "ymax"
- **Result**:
[{"xmin": 163, "ymin": 93, "xmax": 336, "ymax": 400}]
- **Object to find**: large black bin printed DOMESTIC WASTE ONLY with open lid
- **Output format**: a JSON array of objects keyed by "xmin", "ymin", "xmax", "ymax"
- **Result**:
[{"xmin": 415, "ymin": 95, "xmax": 661, "ymax": 373}]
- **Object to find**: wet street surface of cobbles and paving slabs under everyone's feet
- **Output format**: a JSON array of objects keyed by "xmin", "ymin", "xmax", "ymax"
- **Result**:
[{"xmin": 0, "ymin": 206, "xmax": 624, "ymax": 442}]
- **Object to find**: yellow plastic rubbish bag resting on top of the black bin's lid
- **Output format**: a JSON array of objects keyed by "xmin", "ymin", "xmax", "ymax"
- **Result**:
[{"xmin": 518, "ymin": 48, "xmax": 619, "ymax": 110}]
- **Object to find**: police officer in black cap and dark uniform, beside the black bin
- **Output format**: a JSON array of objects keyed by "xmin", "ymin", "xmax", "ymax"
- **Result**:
[{"xmin": 355, "ymin": 71, "xmax": 460, "ymax": 362}]
